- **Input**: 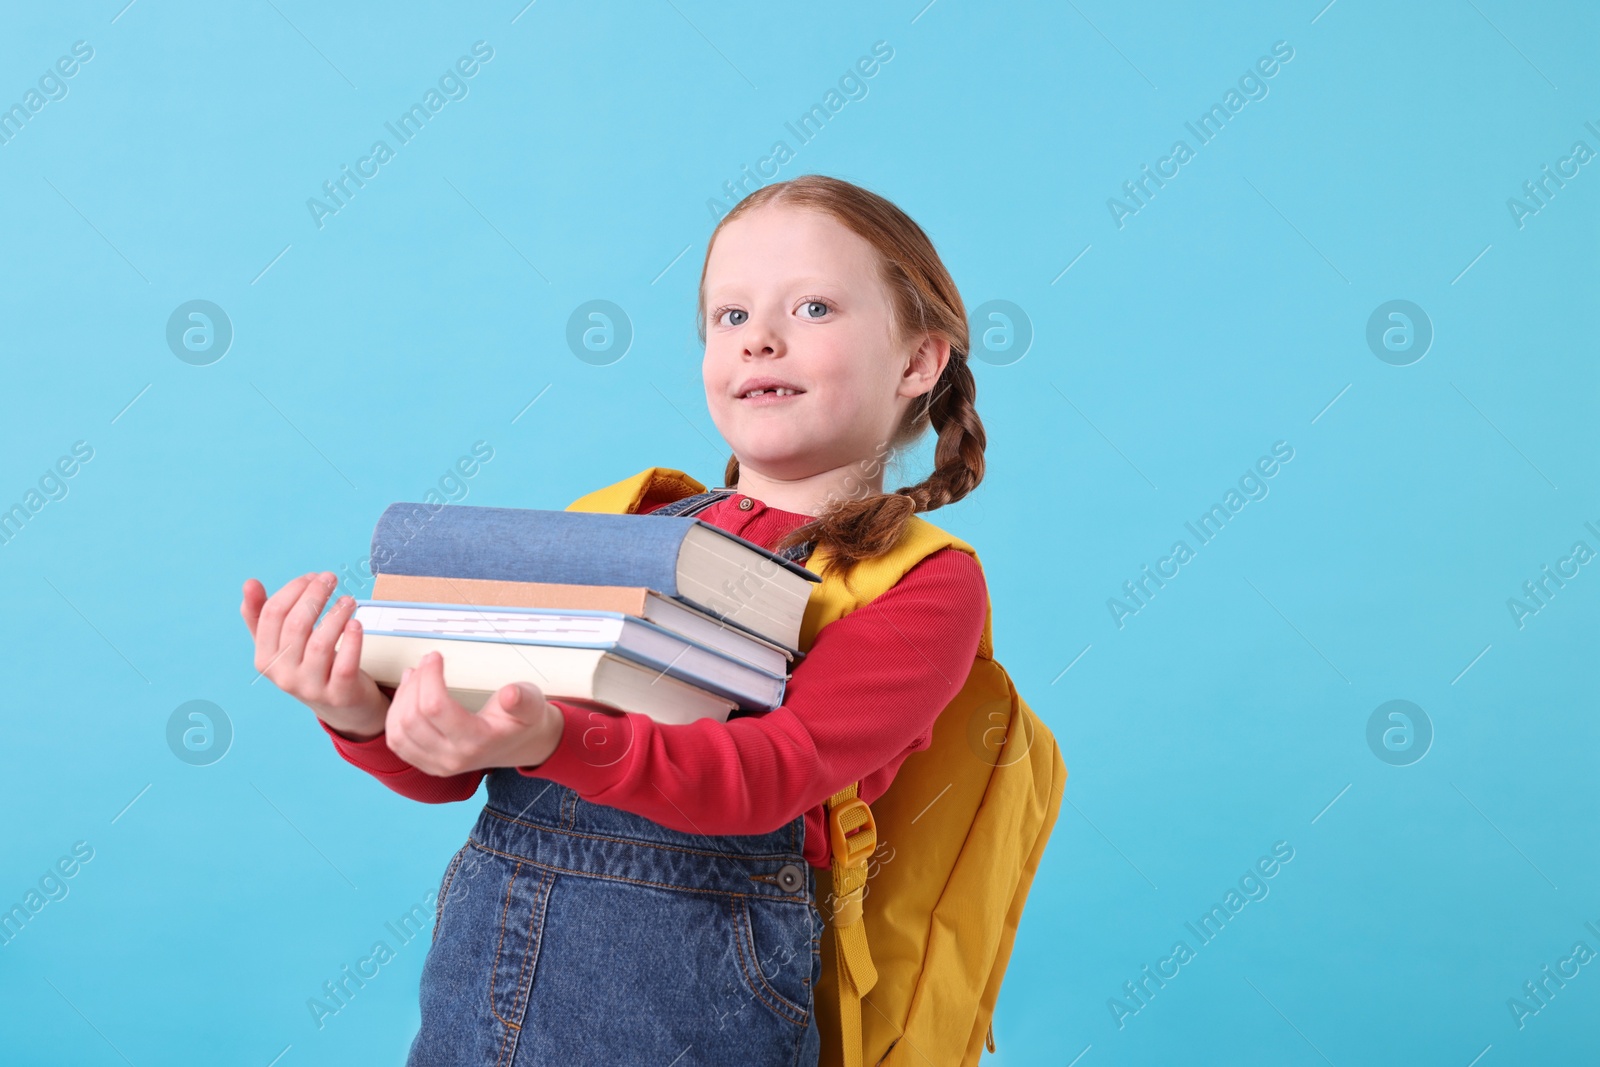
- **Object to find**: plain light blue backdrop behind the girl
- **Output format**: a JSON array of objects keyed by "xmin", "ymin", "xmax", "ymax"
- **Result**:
[{"xmin": 0, "ymin": 0, "xmax": 1600, "ymax": 1067}]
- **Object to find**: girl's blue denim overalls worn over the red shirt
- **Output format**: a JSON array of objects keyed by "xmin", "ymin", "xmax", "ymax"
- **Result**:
[{"xmin": 406, "ymin": 490, "xmax": 824, "ymax": 1067}]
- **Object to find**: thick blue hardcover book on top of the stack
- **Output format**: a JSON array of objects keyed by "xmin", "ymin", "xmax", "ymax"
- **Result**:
[{"xmin": 371, "ymin": 502, "xmax": 822, "ymax": 648}]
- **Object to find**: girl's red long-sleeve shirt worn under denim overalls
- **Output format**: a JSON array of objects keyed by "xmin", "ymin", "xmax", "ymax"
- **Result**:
[{"xmin": 323, "ymin": 493, "xmax": 989, "ymax": 867}]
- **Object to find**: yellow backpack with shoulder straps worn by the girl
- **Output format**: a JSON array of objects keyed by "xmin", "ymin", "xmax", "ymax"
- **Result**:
[{"xmin": 566, "ymin": 467, "xmax": 1067, "ymax": 1067}]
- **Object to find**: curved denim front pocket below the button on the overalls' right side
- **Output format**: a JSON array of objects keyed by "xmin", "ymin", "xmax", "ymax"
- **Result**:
[{"xmin": 730, "ymin": 896, "xmax": 821, "ymax": 1027}]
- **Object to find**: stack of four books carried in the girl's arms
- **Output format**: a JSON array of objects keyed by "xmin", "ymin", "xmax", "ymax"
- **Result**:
[{"xmin": 355, "ymin": 502, "xmax": 821, "ymax": 723}]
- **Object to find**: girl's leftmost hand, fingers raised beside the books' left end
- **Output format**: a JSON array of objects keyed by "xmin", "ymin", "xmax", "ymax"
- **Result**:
[{"xmin": 238, "ymin": 571, "xmax": 389, "ymax": 741}]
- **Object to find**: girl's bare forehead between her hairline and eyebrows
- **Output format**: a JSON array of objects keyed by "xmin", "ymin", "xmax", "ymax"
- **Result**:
[{"xmin": 706, "ymin": 205, "xmax": 877, "ymax": 294}]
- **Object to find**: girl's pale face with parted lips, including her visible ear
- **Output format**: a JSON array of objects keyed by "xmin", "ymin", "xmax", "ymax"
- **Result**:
[{"xmin": 701, "ymin": 205, "xmax": 942, "ymax": 482}]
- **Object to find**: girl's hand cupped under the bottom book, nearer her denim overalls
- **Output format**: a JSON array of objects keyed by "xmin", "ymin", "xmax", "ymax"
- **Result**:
[{"xmin": 384, "ymin": 653, "xmax": 565, "ymax": 777}]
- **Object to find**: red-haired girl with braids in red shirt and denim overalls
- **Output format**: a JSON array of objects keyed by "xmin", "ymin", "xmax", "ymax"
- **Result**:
[{"xmin": 242, "ymin": 174, "xmax": 987, "ymax": 1067}]
